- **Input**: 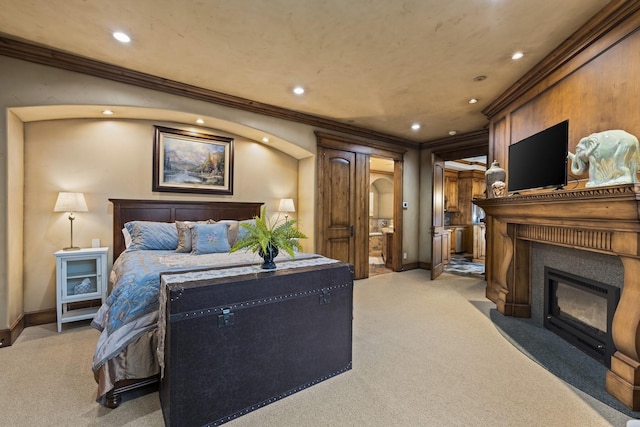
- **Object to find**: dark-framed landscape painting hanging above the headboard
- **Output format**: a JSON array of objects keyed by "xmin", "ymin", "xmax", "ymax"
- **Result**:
[{"xmin": 153, "ymin": 126, "xmax": 233, "ymax": 194}]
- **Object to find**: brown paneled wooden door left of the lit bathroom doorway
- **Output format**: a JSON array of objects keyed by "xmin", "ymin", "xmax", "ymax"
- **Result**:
[{"xmin": 319, "ymin": 148, "xmax": 356, "ymax": 265}]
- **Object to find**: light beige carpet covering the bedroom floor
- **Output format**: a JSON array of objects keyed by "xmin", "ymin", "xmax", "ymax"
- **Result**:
[{"xmin": 0, "ymin": 270, "xmax": 630, "ymax": 427}]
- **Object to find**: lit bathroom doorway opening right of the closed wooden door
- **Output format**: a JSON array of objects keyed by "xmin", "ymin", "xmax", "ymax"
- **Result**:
[{"xmin": 369, "ymin": 156, "xmax": 395, "ymax": 277}]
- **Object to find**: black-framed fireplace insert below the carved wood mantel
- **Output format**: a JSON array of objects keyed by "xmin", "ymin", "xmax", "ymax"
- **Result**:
[{"xmin": 544, "ymin": 267, "xmax": 620, "ymax": 368}]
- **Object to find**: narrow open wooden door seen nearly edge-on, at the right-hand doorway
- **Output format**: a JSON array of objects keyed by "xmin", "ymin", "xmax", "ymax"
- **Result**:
[{"xmin": 431, "ymin": 154, "xmax": 449, "ymax": 280}]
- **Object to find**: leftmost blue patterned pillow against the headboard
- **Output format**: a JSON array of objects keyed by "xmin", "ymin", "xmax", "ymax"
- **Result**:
[{"xmin": 124, "ymin": 221, "xmax": 178, "ymax": 251}]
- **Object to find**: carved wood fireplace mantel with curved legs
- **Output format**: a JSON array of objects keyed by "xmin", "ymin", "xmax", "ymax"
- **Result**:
[{"xmin": 474, "ymin": 184, "xmax": 640, "ymax": 411}]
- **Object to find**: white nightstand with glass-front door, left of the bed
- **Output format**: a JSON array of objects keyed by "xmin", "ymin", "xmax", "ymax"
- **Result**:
[{"xmin": 55, "ymin": 248, "xmax": 109, "ymax": 332}]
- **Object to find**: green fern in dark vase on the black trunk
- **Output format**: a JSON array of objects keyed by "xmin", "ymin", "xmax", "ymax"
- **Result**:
[{"xmin": 230, "ymin": 207, "xmax": 307, "ymax": 270}]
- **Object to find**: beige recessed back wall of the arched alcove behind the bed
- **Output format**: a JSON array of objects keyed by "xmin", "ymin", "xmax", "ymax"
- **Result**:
[{"xmin": 24, "ymin": 119, "xmax": 298, "ymax": 312}]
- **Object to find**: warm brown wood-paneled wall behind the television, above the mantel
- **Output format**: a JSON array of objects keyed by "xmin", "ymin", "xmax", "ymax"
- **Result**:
[{"xmin": 483, "ymin": 0, "xmax": 640, "ymax": 299}]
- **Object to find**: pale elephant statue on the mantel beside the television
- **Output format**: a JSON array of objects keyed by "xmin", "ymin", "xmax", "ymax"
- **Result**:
[{"xmin": 567, "ymin": 130, "xmax": 640, "ymax": 187}]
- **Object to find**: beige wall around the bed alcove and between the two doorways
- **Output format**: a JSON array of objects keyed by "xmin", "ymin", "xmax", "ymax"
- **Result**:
[{"xmin": 0, "ymin": 56, "xmax": 428, "ymax": 330}]
